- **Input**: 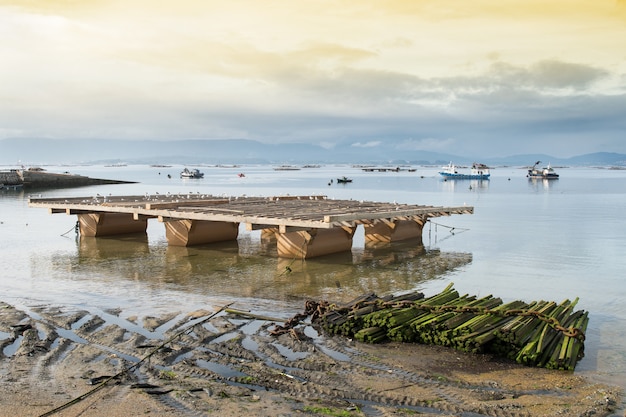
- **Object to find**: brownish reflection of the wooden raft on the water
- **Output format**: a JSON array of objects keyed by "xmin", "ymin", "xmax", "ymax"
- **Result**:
[{"xmin": 67, "ymin": 235, "xmax": 472, "ymax": 307}]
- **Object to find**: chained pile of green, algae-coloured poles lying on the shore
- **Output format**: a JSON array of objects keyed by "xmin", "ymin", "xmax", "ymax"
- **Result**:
[{"xmin": 314, "ymin": 284, "xmax": 589, "ymax": 370}]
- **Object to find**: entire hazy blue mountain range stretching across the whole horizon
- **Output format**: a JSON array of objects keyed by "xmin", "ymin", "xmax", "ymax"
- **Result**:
[{"xmin": 0, "ymin": 138, "xmax": 626, "ymax": 167}]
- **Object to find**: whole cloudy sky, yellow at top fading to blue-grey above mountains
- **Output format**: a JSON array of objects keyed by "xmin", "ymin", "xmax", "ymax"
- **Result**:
[{"xmin": 0, "ymin": 0, "xmax": 626, "ymax": 157}]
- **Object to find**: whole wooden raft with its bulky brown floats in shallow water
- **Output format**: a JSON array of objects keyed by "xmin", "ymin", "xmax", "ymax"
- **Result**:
[{"xmin": 28, "ymin": 193, "xmax": 474, "ymax": 258}]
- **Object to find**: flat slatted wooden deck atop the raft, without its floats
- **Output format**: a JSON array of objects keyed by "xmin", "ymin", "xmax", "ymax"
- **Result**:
[{"xmin": 28, "ymin": 193, "xmax": 474, "ymax": 232}]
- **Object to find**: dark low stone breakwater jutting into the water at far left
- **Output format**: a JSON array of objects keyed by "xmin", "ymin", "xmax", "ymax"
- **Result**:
[{"xmin": 0, "ymin": 169, "xmax": 134, "ymax": 188}]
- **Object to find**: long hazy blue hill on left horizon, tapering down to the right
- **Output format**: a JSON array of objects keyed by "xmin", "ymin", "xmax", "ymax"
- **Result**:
[{"xmin": 0, "ymin": 139, "xmax": 460, "ymax": 165}]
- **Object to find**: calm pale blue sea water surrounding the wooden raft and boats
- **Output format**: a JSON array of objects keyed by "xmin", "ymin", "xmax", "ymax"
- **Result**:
[{"xmin": 0, "ymin": 165, "xmax": 626, "ymax": 394}]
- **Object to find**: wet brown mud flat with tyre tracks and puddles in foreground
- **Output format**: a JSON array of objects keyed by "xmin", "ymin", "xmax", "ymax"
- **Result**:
[{"xmin": 0, "ymin": 301, "xmax": 621, "ymax": 417}]
